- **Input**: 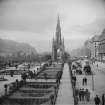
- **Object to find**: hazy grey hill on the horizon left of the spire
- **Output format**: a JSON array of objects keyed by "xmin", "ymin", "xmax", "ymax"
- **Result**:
[{"xmin": 0, "ymin": 39, "xmax": 37, "ymax": 56}]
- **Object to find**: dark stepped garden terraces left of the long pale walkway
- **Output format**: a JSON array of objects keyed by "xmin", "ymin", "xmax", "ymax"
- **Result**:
[{"xmin": 0, "ymin": 62, "xmax": 62, "ymax": 105}]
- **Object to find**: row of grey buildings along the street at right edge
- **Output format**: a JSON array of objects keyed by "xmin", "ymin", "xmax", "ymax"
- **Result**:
[{"xmin": 84, "ymin": 29, "xmax": 105, "ymax": 61}]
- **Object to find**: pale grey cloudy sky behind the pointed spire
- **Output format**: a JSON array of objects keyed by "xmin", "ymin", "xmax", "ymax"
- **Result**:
[{"xmin": 0, "ymin": 0, "xmax": 105, "ymax": 52}]
